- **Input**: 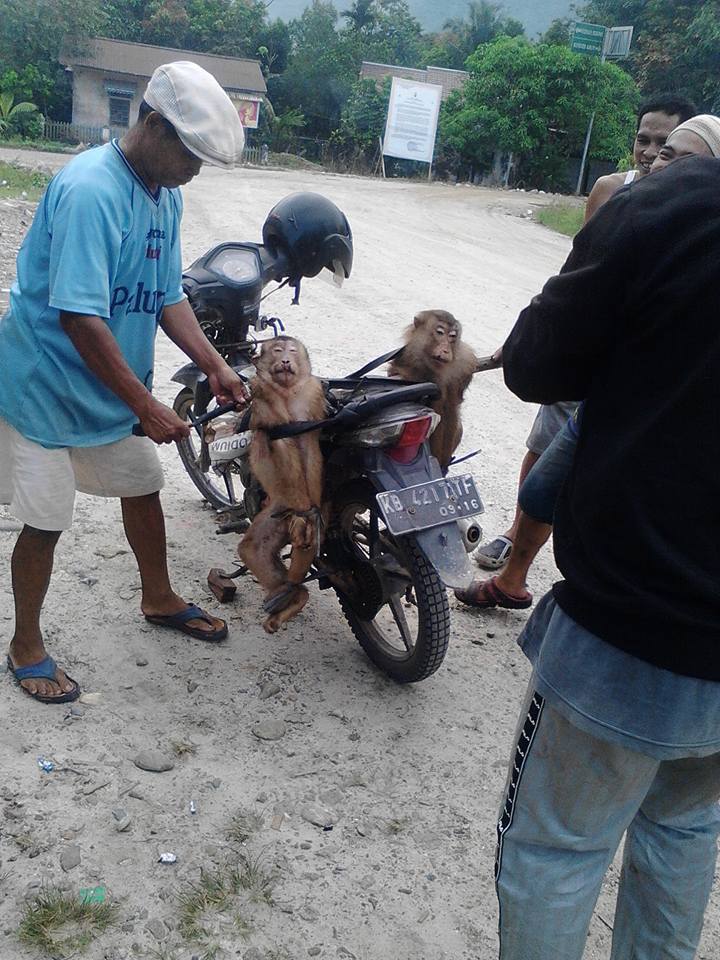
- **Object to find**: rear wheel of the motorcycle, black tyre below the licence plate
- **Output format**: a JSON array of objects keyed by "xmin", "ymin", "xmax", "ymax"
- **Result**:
[{"xmin": 329, "ymin": 482, "xmax": 450, "ymax": 683}]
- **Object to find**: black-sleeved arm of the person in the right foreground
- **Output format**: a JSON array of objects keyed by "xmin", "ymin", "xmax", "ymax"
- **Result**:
[{"xmin": 502, "ymin": 191, "xmax": 642, "ymax": 403}]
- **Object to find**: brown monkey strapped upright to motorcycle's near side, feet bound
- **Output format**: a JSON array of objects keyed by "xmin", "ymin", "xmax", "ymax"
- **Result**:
[{"xmin": 238, "ymin": 337, "xmax": 325, "ymax": 633}]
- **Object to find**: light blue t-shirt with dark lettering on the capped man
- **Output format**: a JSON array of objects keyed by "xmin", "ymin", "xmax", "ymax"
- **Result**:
[{"xmin": 0, "ymin": 141, "xmax": 184, "ymax": 447}]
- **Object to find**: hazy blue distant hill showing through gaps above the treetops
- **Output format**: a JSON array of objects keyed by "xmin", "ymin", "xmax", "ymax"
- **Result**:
[{"xmin": 268, "ymin": 0, "xmax": 572, "ymax": 37}]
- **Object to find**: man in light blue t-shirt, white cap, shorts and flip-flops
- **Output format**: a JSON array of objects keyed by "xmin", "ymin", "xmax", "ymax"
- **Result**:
[{"xmin": 0, "ymin": 61, "xmax": 244, "ymax": 703}]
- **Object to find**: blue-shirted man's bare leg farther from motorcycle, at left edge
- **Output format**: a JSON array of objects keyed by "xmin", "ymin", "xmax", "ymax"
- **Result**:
[{"xmin": 9, "ymin": 525, "xmax": 74, "ymax": 697}]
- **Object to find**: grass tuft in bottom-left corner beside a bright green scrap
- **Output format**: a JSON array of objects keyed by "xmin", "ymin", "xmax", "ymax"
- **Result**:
[{"xmin": 18, "ymin": 887, "xmax": 117, "ymax": 957}]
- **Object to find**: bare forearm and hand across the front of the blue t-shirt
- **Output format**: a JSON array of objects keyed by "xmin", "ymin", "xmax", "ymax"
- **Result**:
[{"xmin": 60, "ymin": 311, "xmax": 190, "ymax": 443}]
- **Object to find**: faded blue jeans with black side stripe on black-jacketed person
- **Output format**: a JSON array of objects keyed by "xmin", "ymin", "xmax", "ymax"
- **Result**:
[{"xmin": 496, "ymin": 681, "xmax": 720, "ymax": 960}]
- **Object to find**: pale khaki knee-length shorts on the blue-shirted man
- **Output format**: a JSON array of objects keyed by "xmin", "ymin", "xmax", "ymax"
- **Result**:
[{"xmin": 0, "ymin": 418, "xmax": 163, "ymax": 530}]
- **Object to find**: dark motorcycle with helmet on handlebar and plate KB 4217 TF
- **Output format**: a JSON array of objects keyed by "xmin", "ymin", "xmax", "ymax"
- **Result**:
[{"xmin": 173, "ymin": 194, "xmax": 492, "ymax": 683}]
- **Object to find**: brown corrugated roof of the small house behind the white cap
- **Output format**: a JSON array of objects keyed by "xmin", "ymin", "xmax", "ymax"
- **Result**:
[{"xmin": 60, "ymin": 37, "xmax": 267, "ymax": 93}]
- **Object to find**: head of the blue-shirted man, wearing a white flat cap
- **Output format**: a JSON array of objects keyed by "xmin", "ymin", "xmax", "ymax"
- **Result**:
[{"xmin": 121, "ymin": 60, "xmax": 245, "ymax": 189}]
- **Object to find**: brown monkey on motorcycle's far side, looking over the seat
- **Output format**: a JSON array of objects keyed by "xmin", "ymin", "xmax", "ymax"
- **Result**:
[{"xmin": 388, "ymin": 310, "xmax": 478, "ymax": 470}]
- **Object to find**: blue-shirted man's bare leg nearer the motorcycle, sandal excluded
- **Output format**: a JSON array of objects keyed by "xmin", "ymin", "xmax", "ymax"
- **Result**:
[{"xmin": 120, "ymin": 493, "xmax": 224, "ymax": 633}]
